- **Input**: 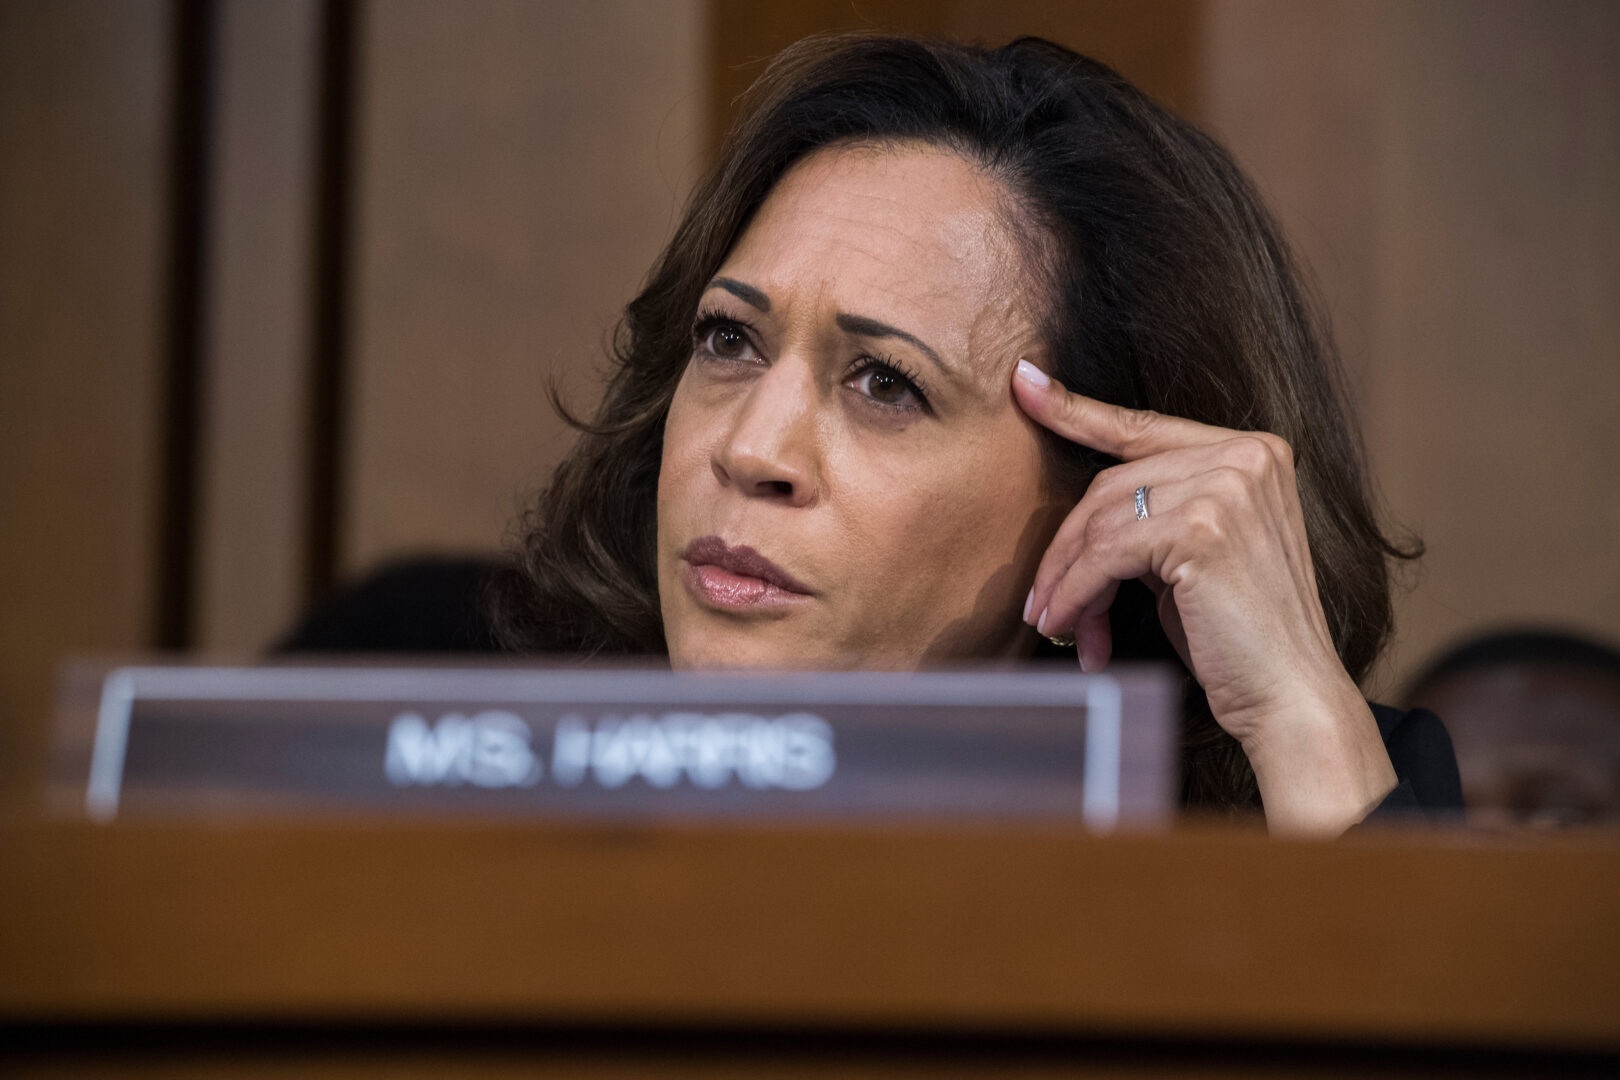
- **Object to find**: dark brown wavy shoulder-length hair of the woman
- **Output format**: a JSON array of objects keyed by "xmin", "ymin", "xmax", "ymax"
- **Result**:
[{"xmin": 496, "ymin": 36, "xmax": 1418, "ymax": 808}]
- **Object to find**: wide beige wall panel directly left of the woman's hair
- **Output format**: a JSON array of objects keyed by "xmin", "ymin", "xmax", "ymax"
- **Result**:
[{"xmin": 340, "ymin": 0, "xmax": 708, "ymax": 572}]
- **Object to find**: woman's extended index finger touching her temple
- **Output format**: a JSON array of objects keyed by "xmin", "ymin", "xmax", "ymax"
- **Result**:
[{"xmin": 1013, "ymin": 359, "xmax": 1236, "ymax": 461}]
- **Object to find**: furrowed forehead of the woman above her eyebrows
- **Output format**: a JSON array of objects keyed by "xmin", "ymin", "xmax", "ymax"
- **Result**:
[{"xmin": 721, "ymin": 144, "xmax": 1025, "ymax": 362}]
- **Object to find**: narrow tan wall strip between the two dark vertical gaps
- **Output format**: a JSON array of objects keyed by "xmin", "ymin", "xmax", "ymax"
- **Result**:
[{"xmin": 194, "ymin": 0, "xmax": 322, "ymax": 654}]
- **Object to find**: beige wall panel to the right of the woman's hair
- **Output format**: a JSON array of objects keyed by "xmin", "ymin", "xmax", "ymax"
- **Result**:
[{"xmin": 1202, "ymin": 0, "xmax": 1620, "ymax": 687}]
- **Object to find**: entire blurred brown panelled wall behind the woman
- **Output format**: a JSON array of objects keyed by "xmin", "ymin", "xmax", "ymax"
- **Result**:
[{"xmin": 0, "ymin": 0, "xmax": 1620, "ymax": 806}]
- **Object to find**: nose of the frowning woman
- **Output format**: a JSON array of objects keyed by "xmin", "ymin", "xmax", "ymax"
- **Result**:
[{"xmin": 710, "ymin": 358, "xmax": 820, "ymax": 507}]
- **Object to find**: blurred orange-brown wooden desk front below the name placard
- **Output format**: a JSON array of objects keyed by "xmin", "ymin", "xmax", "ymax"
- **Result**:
[{"xmin": 0, "ymin": 821, "xmax": 1620, "ymax": 1075}]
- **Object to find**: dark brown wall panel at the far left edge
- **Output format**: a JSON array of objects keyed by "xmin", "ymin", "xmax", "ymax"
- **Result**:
[{"xmin": 0, "ymin": 0, "xmax": 172, "ymax": 801}]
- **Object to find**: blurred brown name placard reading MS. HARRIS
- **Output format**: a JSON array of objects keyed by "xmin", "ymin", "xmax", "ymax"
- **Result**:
[{"xmin": 86, "ymin": 667, "xmax": 1178, "ymax": 829}]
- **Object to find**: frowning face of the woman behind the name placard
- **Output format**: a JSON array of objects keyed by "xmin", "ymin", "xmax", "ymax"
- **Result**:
[{"xmin": 658, "ymin": 146, "xmax": 1068, "ymax": 669}]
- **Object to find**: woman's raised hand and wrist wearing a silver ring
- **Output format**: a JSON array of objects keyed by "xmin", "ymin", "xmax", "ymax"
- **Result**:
[{"xmin": 1013, "ymin": 361, "xmax": 1395, "ymax": 832}]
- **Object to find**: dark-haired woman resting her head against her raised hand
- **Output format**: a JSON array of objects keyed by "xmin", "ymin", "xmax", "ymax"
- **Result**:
[{"xmin": 489, "ymin": 29, "xmax": 1455, "ymax": 832}]
